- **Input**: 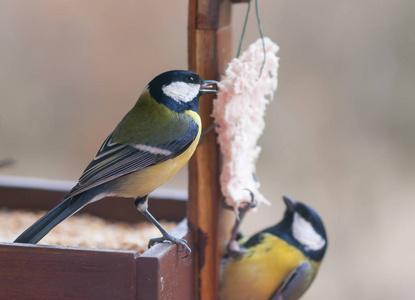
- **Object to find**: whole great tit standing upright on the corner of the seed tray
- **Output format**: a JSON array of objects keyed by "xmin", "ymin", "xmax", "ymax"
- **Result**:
[{"xmin": 15, "ymin": 70, "xmax": 217, "ymax": 256}]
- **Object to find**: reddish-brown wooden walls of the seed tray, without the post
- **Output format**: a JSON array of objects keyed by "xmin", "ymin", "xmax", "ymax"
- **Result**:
[{"xmin": 0, "ymin": 186, "xmax": 195, "ymax": 300}]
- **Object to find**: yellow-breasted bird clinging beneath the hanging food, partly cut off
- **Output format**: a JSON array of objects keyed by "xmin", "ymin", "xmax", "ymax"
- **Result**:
[{"xmin": 220, "ymin": 196, "xmax": 327, "ymax": 300}]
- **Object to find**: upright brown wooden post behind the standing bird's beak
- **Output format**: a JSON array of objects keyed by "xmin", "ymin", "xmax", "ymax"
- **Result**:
[{"xmin": 187, "ymin": 0, "xmax": 232, "ymax": 300}]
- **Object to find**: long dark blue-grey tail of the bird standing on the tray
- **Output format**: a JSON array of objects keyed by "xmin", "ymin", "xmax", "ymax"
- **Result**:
[{"xmin": 14, "ymin": 194, "xmax": 88, "ymax": 244}]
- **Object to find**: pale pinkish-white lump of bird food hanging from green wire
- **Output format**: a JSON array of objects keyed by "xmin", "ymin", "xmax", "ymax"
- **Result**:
[{"xmin": 212, "ymin": 38, "xmax": 279, "ymax": 210}]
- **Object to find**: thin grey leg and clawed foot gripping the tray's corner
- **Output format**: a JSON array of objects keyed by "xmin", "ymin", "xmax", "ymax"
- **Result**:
[{"xmin": 135, "ymin": 195, "xmax": 192, "ymax": 258}]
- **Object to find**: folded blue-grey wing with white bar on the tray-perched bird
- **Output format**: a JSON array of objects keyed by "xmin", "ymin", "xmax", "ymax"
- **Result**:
[{"xmin": 65, "ymin": 110, "xmax": 199, "ymax": 199}]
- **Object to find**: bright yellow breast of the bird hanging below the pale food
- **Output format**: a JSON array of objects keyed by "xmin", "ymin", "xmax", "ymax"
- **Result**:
[{"xmin": 221, "ymin": 234, "xmax": 316, "ymax": 300}]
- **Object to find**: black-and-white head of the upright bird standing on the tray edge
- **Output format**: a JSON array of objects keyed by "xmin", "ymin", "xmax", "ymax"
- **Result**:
[{"xmin": 147, "ymin": 70, "xmax": 218, "ymax": 113}]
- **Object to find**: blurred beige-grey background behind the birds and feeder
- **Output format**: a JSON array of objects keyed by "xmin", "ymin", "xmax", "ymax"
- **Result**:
[{"xmin": 0, "ymin": 0, "xmax": 415, "ymax": 300}]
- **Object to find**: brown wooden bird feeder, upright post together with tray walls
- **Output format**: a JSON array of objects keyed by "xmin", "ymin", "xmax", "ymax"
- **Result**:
[{"xmin": 0, "ymin": 0, "xmax": 240, "ymax": 300}]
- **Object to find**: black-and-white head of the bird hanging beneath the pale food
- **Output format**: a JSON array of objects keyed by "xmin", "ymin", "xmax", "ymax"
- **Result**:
[{"xmin": 281, "ymin": 195, "xmax": 327, "ymax": 261}]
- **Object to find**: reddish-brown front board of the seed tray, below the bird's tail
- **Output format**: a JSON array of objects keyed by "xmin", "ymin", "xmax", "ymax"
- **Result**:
[{"xmin": 0, "ymin": 243, "xmax": 137, "ymax": 299}]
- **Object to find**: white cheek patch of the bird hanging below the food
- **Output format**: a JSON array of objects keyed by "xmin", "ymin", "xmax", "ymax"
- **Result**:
[{"xmin": 293, "ymin": 213, "xmax": 326, "ymax": 251}]
